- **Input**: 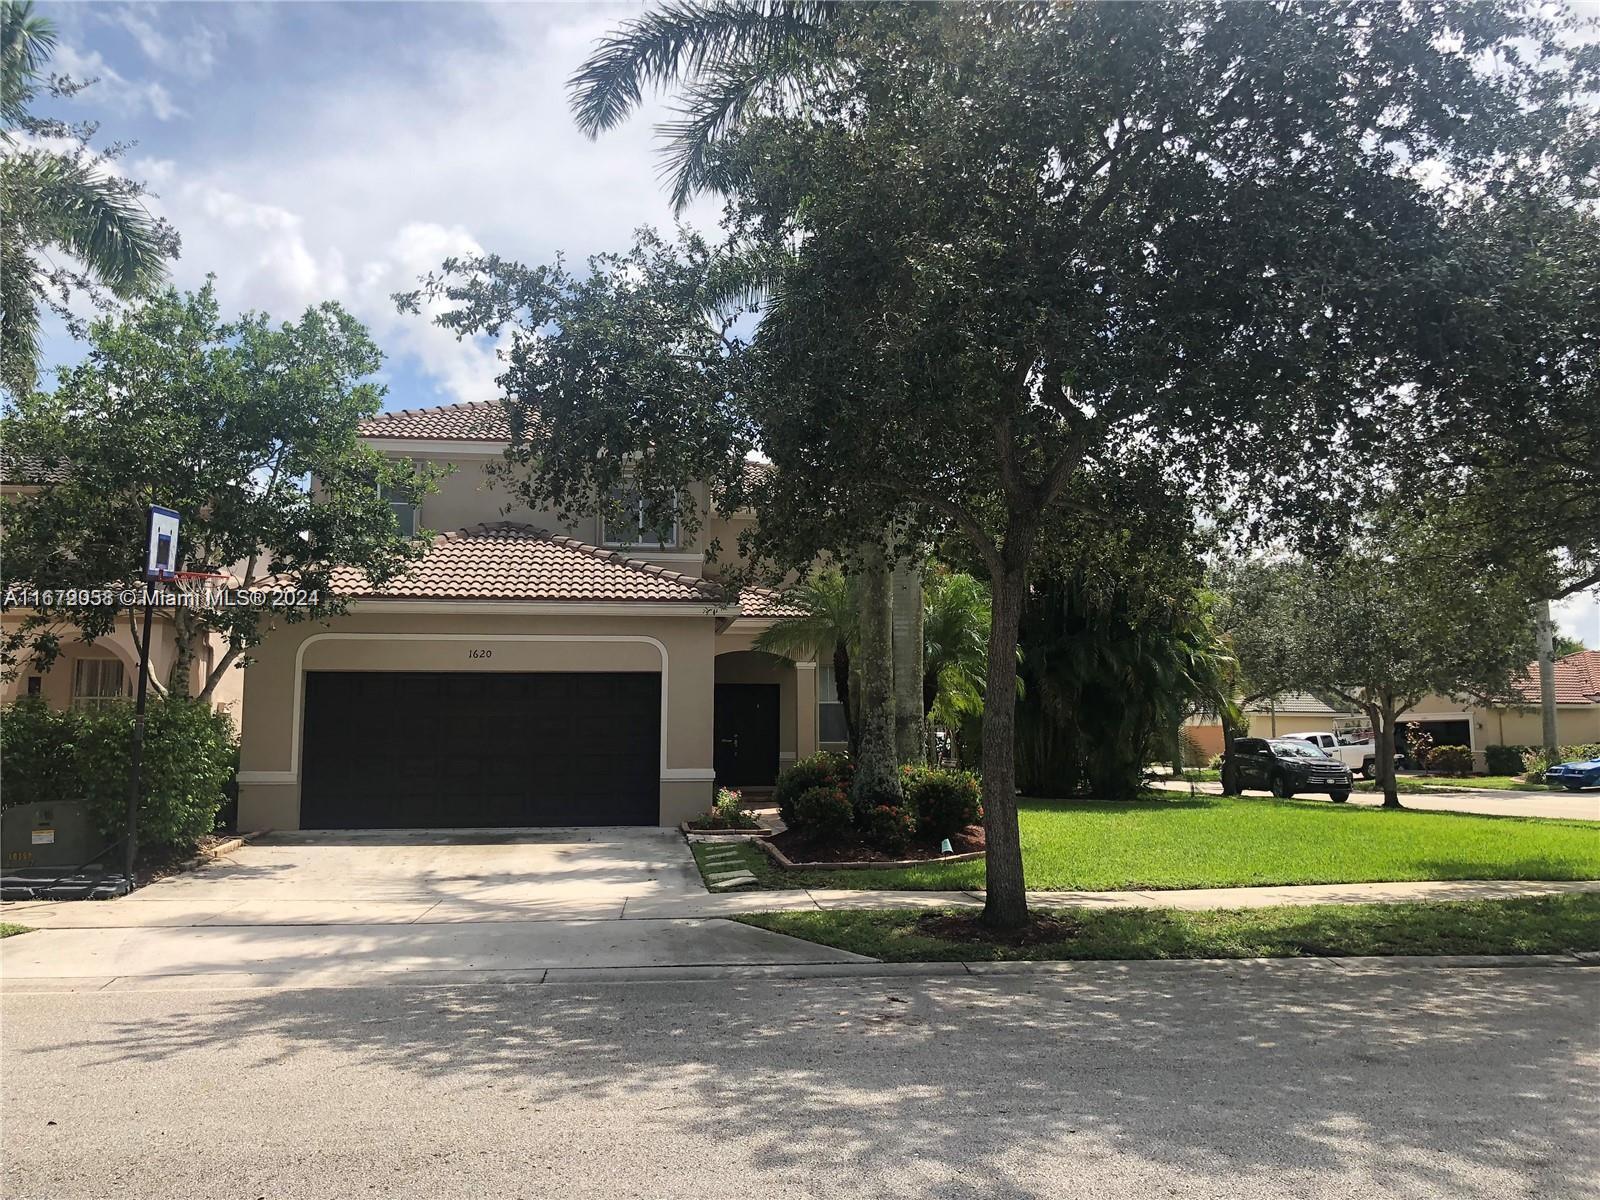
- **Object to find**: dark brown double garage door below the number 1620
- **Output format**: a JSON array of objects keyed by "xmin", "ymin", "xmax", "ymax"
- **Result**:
[{"xmin": 301, "ymin": 670, "xmax": 661, "ymax": 829}]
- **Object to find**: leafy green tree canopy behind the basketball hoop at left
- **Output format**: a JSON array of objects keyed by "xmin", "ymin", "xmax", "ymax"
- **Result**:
[{"xmin": 0, "ymin": 283, "xmax": 435, "ymax": 696}]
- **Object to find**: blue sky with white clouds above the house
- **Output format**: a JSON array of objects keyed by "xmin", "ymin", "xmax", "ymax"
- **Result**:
[{"xmin": 25, "ymin": 3, "xmax": 1600, "ymax": 646}]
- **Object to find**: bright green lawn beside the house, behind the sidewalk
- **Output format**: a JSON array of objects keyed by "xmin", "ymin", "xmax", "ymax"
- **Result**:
[{"xmin": 696, "ymin": 794, "xmax": 1600, "ymax": 891}]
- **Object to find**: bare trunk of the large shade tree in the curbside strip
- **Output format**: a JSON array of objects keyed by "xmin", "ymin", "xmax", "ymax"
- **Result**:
[{"xmin": 982, "ymin": 566, "xmax": 1027, "ymax": 930}]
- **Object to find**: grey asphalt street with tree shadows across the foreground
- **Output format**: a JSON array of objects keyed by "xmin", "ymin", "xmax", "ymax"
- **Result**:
[{"xmin": 0, "ymin": 962, "xmax": 1600, "ymax": 1200}]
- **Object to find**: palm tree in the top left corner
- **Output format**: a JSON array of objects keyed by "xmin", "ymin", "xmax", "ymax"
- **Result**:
[{"xmin": 0, "ymin": 0, "xmax": 174, "ymax": 394}]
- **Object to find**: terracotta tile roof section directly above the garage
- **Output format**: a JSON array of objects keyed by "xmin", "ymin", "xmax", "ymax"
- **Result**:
[{"xmin": 333, "ymin": 522, "xmax": 722, "ymax": 605}]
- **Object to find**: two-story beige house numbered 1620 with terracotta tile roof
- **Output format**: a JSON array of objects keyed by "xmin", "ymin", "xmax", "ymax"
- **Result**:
[{"xmin": 238, "ymin": 402, "xmax": 818, "ymax": 829}]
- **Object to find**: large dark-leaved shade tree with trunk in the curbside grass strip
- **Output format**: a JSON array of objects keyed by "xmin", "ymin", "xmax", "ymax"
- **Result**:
[{"xmin": 416, "ymin": 0, "xmax": 1600, "ymax": 926}]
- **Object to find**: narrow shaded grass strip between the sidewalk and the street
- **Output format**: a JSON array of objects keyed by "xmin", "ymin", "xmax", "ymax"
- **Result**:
[{"xmin": 736, "ymin": 894, "xmax": 1600, "ymax": 962}]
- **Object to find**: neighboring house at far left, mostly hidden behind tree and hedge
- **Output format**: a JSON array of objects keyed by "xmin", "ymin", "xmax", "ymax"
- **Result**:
[{"xmin": 0, "ymin": 454, "xmax": 245, "ymax": 722}]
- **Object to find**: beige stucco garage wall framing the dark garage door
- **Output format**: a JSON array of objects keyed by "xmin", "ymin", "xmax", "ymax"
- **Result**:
[{"xmin": 238, "ymin": 605, "xmax": 715, "ymax": 829}]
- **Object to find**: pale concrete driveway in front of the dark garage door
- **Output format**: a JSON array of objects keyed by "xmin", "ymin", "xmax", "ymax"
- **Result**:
[{"xmin": 0, "ymin": 827, "xmax": 861, "ymax": 990}]
